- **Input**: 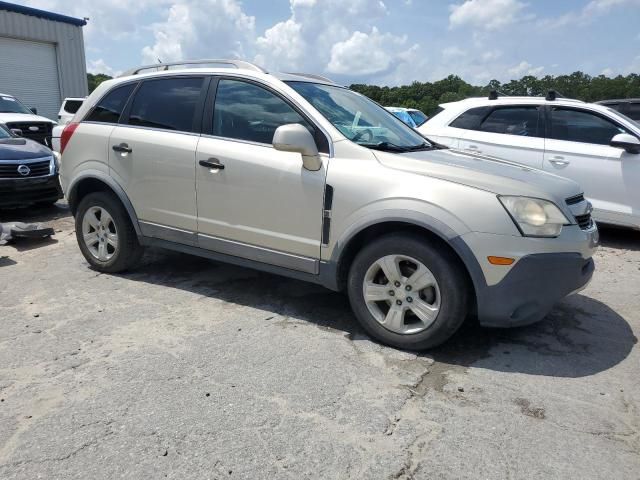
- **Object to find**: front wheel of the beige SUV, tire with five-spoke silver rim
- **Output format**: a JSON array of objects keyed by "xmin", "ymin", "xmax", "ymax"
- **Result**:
[{"xmin": 347, "ymin": 234, "xmax": 472, "ymax": 350}]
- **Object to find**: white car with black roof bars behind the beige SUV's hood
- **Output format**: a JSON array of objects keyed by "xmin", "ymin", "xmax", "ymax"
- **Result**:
[{"xmin": 420, "ymin": 93, "xmax": 640, "ymax": 232}]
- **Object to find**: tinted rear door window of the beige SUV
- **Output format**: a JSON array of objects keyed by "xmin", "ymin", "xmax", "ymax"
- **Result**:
[{"xmin": 128, "ymin": 77, "xmax": 203, "ymax": 132}]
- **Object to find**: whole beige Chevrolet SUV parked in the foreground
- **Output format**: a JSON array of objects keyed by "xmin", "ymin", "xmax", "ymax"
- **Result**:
[{"xmin": 61, "ymin": 60, "xmax": 598, "ymax": 349}]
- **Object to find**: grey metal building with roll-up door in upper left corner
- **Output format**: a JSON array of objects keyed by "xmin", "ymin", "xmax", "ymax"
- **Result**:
[{"xmin": 0, "ymin": 1, "xmax": 88, "ymax": 121}]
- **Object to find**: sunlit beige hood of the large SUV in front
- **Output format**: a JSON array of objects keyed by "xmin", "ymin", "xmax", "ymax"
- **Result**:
[{"xmin": 374, "ymin": 150, "xmax": 582, "ymax": 205}]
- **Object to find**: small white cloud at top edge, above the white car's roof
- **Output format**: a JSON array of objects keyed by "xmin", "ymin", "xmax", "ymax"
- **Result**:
[{"xmin": 449, "ymin": 0, "xmax": 527, "ymax": 30}]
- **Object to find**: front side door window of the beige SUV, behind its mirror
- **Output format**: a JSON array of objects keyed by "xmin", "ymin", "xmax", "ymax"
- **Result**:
[{"xmin": 213, "ymin": 80, "xmax": 314, "ymax": 144}]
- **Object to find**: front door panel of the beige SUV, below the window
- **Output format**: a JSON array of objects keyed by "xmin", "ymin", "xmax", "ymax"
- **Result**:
[{"xmin": 196, "ymin": 137, "xmax": 326, "ymax": 258}]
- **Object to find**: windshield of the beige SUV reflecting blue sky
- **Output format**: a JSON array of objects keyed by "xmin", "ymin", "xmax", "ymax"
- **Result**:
[{"xmin": 287, "ymin": 82, "xmax": 431, "ymax": 151}]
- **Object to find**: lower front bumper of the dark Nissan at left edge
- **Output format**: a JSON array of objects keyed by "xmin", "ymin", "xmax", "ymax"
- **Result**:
[{"xmin": 0, "ymin": 174, "xmax": 62, "ymax": 208}]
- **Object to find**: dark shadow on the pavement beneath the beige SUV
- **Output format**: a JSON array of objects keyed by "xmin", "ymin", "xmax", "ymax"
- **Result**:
[{"xmin": 123, "ymin": 250, "xmax": 637, "ymax": 377}]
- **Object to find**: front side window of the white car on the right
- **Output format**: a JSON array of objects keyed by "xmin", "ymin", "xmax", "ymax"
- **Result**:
[{"xmin": 550, "ymin": 108, "xmax": 628, "ymax": 145}]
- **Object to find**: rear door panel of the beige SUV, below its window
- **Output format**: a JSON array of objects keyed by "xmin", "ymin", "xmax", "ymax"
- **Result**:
[{"xmin": 109, "ymin": 125, "xmax": 199, "ymax": 232}]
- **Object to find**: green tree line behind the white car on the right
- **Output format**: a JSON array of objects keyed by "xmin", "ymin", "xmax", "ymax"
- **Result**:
[{"xmin": 351, "ymin": 72, "xmax": 640, "ymax": 115}]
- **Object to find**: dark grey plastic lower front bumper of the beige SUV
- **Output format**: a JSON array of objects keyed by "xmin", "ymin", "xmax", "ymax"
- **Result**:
[{"xmin": 476, "ymin": 253, "xmax": 595, "ymax": 327}]
